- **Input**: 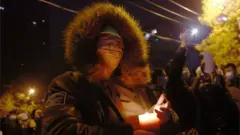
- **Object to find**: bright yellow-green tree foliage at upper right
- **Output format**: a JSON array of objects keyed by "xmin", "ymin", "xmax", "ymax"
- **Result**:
[{"xmin": 196, "ymin": 0, "xmax": 240, "ymax": 66}]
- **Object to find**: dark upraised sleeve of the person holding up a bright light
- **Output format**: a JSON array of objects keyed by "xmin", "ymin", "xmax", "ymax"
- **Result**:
[{"xmin": 168, "ymin": 47, "xmax": 187, "ymax": 82}]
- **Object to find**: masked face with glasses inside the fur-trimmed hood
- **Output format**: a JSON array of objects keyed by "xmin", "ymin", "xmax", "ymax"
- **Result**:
[{"xmin": 97, "ymin": 35, "xmax": 123, "ymax": 79}]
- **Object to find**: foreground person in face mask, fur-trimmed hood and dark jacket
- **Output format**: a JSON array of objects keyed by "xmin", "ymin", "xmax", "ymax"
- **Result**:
[{"xmin": 42, "ymin": 3, "xmax": 174, "ymax": 135}]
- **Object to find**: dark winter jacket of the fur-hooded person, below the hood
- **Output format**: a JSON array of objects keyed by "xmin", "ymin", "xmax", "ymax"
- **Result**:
[{"xmin": 42, "ymin": 72, "xmax": 133, "ymax": 135}]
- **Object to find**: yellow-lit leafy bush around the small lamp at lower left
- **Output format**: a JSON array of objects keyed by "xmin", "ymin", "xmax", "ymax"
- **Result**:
[{"xmin": 0, "ymin": 92, "xmax": 43, "ymax": 135}]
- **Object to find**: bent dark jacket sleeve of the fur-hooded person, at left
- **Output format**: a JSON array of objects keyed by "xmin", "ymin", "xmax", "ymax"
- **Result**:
[{"xmin": 41, "ymin": 72, "xmax": 133, "ymax": 135}]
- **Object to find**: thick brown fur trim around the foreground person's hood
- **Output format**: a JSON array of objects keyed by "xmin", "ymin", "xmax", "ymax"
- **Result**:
[{"xmin": 65, "ymin": 3, "xmax": 148, "ymax": 71}]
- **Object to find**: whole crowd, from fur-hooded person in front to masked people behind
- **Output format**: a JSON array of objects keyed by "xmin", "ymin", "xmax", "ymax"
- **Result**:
[{"xmin": 0, "ymin": 3, "xmax": 240, "ymax": 135}]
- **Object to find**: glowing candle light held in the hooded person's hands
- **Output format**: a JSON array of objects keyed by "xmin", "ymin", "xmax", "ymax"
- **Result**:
[{"xmin": 138, "ymin": 113, "xmax": 161, "ymax": 129}]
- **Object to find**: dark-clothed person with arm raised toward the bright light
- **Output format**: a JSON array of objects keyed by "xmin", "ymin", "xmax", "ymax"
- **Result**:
[{"xmin": 166, "ymin": 33, "xmax": 198, "ymax": 132}]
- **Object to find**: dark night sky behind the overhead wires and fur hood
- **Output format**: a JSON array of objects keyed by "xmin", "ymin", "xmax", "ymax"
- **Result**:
[{"xmin": 1, "ymin": 0, "xmax": 204, "ymax": 94}]
